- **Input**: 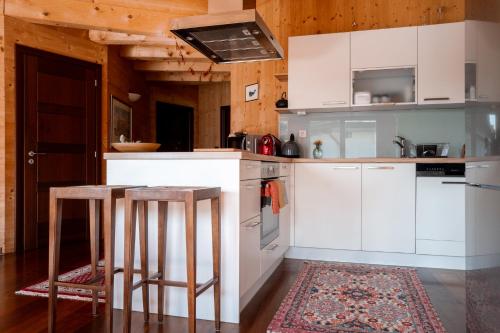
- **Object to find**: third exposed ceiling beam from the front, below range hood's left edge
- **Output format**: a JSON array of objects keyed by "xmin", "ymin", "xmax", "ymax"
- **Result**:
[{"xmin": 134, "ymin": 61, "xmax": 231, "ymax": 73}]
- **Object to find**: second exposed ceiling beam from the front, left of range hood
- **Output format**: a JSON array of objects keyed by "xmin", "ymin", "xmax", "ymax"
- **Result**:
[{"xmin": 120, "ymin": 45, "xmax": 208, "ymax": 62}]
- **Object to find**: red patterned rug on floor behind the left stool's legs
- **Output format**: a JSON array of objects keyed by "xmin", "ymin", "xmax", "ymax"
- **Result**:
[{"xmin": 16, "ymin": 261, "xmax": 105, "ymax": 303}]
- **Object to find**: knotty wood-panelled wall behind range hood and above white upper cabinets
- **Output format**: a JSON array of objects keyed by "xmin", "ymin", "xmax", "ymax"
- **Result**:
[{"xmin": 231, "ymin": 0, "xmax": 464, "ymax": 134}]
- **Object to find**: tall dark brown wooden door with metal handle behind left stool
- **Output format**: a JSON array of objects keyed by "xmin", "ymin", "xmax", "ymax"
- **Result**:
[{"xmin": 16, "ymin": 46, "xmax": 101, "ymax": 250}]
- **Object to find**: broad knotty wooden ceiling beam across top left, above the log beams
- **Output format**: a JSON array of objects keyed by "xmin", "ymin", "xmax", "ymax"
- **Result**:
[{"xmin": 5, "ymin": 0, "xmax": 206, "ymax": 36}]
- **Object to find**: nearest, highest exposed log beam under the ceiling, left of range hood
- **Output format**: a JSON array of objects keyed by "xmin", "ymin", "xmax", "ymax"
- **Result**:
[{"xmin": 89, "ymin": 30, "xmax": 181, "ymax": 46}]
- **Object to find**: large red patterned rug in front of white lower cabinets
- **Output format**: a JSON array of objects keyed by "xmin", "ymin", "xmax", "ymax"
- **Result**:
[{"xmin": 267, "ymin": 263, "xmax": 446, "ymax": 333}]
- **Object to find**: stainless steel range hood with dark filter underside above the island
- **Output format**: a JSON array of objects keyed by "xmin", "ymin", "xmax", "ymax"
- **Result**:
[{"xmin": 172, "ymin": 9, "xmax": 283, "ymax": 63}]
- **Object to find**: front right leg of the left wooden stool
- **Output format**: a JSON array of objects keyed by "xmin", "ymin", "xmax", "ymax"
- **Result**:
[{"xmin": 104, "ymin": 194, "xmax": 116, "ymax": 333}]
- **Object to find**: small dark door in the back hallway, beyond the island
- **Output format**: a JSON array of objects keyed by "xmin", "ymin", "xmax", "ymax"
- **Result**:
[{"xmin": 156, "ymin": 102, "xmax": 194, "ymax": 151}]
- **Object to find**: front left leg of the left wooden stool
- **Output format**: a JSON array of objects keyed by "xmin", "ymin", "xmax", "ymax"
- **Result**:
[{"xmin": 48, "ymin": 191, "xmax": 62, "ymax": 332}]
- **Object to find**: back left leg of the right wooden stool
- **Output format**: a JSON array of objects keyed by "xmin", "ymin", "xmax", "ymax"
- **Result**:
[{"xmin": 138, "ymin": 201, "xmax": 149, "ymax": 321}]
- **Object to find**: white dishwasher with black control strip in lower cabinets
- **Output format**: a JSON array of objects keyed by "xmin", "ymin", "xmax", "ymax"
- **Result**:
[{"xmin": 416, "ymin": 163, "xmax": 466, "ymax": 256}]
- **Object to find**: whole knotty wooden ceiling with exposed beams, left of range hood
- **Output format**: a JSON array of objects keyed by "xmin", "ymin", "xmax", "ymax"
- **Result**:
[{"xmin": 4, "ymin": 0, "xmax": 230, "ymax": 84}]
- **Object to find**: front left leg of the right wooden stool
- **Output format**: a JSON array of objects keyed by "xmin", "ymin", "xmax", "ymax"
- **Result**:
[{"xmin": 123, "ymin": 195, "xmax": 137, "ymax": 333}]
